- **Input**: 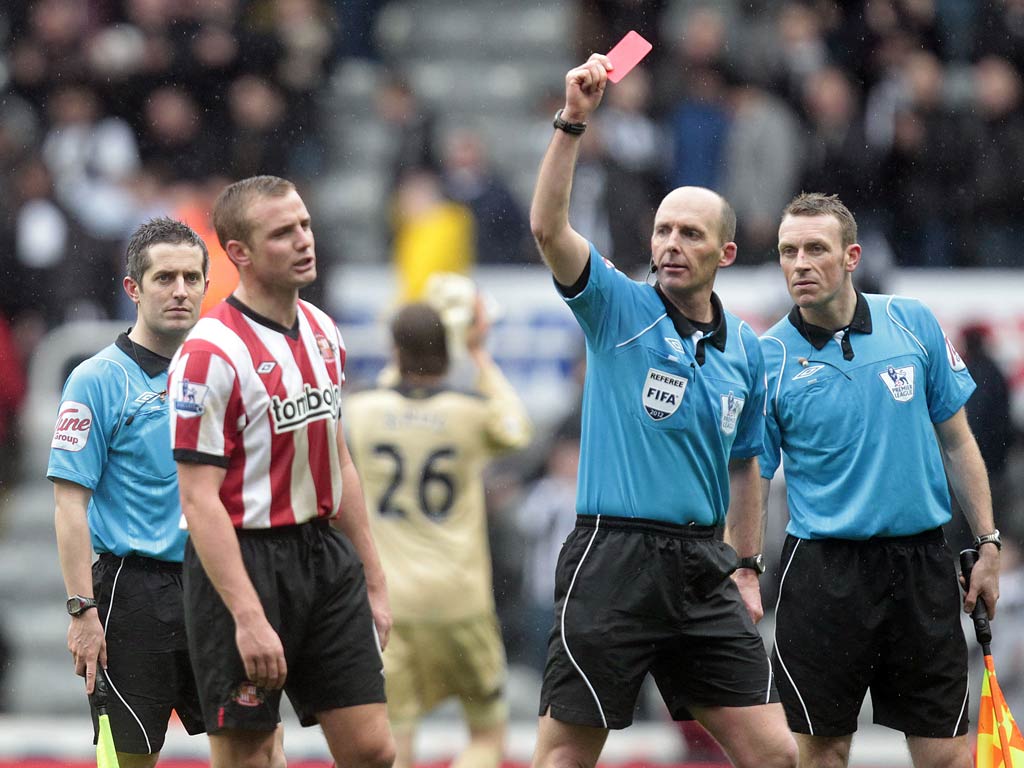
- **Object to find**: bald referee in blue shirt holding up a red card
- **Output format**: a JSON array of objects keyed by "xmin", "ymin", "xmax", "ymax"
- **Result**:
[{"xmin": 530, "ymin": 54, "xmax": 797, "ymax": 768}]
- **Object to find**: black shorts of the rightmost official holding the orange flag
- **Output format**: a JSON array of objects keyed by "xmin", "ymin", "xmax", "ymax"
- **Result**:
[{"xmin": 773, "ymin": 528, "xmax": 968, "ymax": 738}]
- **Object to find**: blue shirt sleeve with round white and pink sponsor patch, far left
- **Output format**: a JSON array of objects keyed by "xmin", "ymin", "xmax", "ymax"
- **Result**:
[{"xmin": 46, "ymin": 358, "xmax": 120, "ymax": 490}]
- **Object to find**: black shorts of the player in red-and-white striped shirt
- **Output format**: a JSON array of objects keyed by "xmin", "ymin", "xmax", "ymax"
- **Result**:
[{"xmin": 184, "ymin": 520, "xmax": 384, "ymax": 733}]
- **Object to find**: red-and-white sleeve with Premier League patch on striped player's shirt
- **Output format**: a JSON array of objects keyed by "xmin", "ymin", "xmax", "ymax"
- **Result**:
[{"xmin": 174, "ymin": 342, "xmax": 245, "ymax": 467}]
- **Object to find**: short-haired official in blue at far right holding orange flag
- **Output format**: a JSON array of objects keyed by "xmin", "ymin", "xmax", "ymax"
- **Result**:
[{"xmin": 761, "ymin": 194, "xmax": 1000, "ymax": 768}]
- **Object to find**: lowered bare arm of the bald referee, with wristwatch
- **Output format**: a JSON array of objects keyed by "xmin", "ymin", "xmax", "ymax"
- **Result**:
[{"xmin": 725, "ymin": 458, "xmax": 765, "ymax": 623}]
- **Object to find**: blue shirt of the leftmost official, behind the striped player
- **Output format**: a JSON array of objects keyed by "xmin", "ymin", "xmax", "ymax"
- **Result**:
[{"xmin": 46, "ymin": 334, "xmax": 187, "ymax": 562}]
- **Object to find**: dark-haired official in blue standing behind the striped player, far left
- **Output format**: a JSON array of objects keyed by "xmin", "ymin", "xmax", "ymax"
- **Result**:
[{"xmin": 46, "ymin": 218, "xmax": 209, "ymax": 768}]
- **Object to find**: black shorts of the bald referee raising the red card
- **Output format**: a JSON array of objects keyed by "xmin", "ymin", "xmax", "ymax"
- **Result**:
[{"xmin": 540, "ymin": 515, "xmax": 778, "ymax": 728}]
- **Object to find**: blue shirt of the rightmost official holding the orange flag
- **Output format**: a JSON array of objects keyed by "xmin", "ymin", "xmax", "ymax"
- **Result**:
[{"xmin": 761, "ymin": 294, "xmax": 975, "ymax": 539}]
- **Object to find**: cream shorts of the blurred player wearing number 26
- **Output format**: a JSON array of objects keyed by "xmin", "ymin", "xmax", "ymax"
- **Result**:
[{"xmin": 384, "ymin": 613, "xmax": 508, "ymax": 729}]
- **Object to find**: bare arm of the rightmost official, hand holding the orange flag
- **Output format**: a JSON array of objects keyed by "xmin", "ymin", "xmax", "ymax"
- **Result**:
[{"xmin": 935, "ymin": 408, "xmax": 999, "ymax": 617}]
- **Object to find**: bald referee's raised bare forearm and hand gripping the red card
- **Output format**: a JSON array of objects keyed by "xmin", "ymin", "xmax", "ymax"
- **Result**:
[{"xmin": 529, "ymin": 53, "xmax": 611, "ymax": 286}]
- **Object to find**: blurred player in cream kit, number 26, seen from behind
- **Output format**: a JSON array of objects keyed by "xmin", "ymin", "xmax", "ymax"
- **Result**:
[{"xmin": 345, "ymin": 301, "xmax": 531, "ymax": 768}]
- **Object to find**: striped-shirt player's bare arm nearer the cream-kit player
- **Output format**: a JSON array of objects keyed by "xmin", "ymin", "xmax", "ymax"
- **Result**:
[{"xmin": 331, "ymin": 429, "xmax": 391, "ymax": 650}]
